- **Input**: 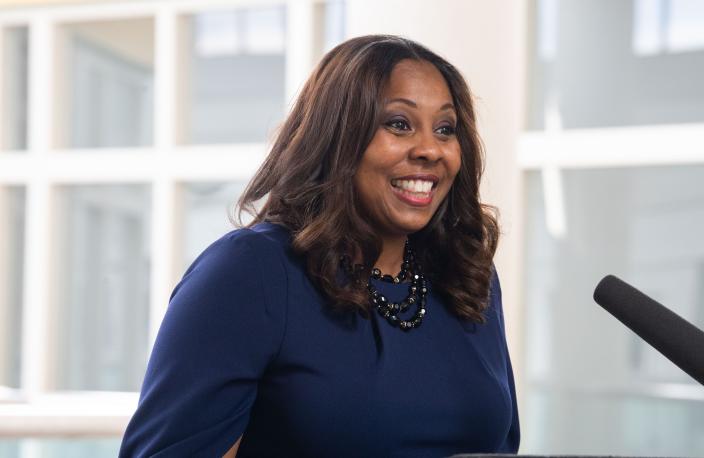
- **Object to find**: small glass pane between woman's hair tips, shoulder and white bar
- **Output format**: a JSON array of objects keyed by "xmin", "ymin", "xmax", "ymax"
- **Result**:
[{"xmin": 180, "ymin": 182, "xmax": 249, "ymax": 270}]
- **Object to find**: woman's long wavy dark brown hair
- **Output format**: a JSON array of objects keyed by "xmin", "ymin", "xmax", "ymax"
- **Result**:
[{"xmin": 238, "ymin": 35, "xmax": 499, "ymax": 322}]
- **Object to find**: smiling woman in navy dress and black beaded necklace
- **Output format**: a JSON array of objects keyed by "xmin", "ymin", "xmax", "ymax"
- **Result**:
[{"xmin": 121, "ymin": 36, "xmax": 519, "ymax": 457}]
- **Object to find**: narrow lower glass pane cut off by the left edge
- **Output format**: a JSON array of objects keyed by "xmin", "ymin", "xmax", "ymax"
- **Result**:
[{"xmin": 0, "ymin": 187, "xmax": 25, "ymax": 388}]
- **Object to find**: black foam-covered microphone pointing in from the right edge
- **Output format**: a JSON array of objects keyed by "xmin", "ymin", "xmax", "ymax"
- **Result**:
[{"xmin": 594, "ymin": 275, "xmax": 704, "ymax": 385}]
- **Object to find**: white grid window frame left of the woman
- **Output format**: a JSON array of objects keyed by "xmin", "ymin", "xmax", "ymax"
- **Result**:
[{"xmin": 0, "ymin": 0, "xmax": 334, "ymax": 437}]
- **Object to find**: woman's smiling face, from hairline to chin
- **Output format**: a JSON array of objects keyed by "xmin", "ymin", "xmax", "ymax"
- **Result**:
[{"xmin": 354, "ymin": 59, "xmax": 461, "ymax": 240}]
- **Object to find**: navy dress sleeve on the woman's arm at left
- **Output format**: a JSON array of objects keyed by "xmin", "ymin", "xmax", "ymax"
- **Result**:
[{"xmin": 120, "ymin": 229, "xmax": 287, "ymax": 457}]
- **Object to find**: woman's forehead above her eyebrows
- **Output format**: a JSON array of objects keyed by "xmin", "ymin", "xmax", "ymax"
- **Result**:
[{"xmin": 384, "ymin": 59, "xmax": 452, "ymax": 104}]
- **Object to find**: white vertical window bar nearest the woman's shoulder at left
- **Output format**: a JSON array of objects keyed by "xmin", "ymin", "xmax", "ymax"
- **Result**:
[{"xmin": 149, "ymin": 5, "xmax": 177, "ymax": 342}]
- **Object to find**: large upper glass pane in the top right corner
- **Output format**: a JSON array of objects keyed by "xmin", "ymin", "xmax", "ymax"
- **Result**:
[{"xmin": 528, "ymin": 0, "xmax": 704, "ymax": 129}]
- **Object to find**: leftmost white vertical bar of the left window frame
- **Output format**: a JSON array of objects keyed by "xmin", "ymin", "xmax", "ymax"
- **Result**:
[{"xmin": 21, "ymin": 14, "xmax": 54, "ymax": 401}]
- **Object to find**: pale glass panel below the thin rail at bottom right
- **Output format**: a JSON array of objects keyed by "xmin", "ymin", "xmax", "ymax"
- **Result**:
[{"xmin": 521, "ymin": 387, "xmax": 704, "ymax": 457}]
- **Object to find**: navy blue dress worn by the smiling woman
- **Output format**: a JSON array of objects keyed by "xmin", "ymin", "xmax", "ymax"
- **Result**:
[{"xmin": 120, "ymin": 223, "xmax": 520, "ymax": 457}]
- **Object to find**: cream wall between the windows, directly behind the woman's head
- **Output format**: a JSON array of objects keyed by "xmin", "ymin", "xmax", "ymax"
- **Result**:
[{"xmin": 347, "ymin": 0, "xmax": 526, "ymax": 372}]
